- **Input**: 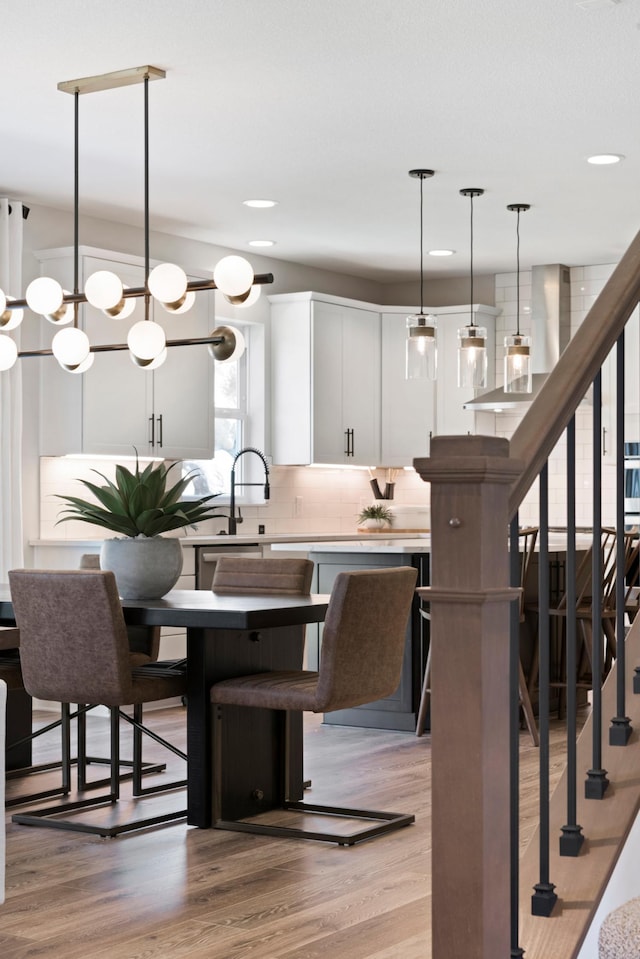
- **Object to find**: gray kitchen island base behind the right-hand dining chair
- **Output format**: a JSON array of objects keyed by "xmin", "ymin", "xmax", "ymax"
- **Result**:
[{"xmin": 306, "ymin": 548, "xmax": 429, "ymax": 732}]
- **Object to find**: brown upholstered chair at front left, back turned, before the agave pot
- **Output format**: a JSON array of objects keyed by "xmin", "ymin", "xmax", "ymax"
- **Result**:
[{"xmin": 9, "ymin": 569, "xmax": 186, "ymax": 836}]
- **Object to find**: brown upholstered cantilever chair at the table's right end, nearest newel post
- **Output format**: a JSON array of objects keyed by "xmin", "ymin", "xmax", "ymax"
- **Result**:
[{"xmin": 211, "ymin": 567, "xmax": 417, "ymax": 846}]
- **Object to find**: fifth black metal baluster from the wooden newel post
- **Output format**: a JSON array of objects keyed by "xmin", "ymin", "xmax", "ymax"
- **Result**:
[{"xmin": 609, "ymin": 330, "xmax": 632, "ymax": 746}]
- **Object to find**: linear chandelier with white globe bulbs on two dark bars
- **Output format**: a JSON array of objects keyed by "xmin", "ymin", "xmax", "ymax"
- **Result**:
[{"xmin": 0, "ymin": 65, "xmax": 273, "ymax": 373}]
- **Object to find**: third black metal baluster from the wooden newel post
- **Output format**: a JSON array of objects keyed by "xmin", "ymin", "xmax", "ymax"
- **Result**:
[{"xmin": 560, "ymin": 416, "xmax": 584, "ymax": 856}]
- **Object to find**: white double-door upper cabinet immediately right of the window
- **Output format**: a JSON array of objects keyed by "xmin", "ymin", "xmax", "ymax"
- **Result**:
[{"xmin": 269, "ymin": 293, "xmax": 381, "ymax": 466}]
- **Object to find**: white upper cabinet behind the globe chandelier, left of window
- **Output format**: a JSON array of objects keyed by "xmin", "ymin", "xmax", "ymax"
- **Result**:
[{"xmin": 39, "ymin": 248, "xmax": 215, "ymax": 459}]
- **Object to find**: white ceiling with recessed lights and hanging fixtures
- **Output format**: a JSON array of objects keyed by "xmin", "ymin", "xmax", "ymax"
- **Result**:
[{"xmin": 5, "ymin": 0, "xmax": 640, "ymax": 282}]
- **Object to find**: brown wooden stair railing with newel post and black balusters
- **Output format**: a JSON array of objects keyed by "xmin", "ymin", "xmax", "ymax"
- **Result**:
[{"xmin": 414, "ymin": 234, "xmax": 640, "ymax": 959}]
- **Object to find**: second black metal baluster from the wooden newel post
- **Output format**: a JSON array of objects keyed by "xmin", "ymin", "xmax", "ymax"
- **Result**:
[{"xmin": 531, "ymin": 464, "xmax": 558, "ymax": 916}]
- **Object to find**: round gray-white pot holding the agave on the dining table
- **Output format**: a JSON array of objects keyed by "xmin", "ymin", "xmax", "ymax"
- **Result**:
[{"xmin": 100, "ymin": 536, "xmax": 182, "ymax": 599}]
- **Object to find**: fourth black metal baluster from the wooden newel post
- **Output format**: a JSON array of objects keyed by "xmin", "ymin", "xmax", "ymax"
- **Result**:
[{"xmin": 584, "ymin": 372, "xmax": 609, "ymax": 799}]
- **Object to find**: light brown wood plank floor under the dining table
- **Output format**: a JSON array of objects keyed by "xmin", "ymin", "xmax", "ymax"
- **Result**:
[{"xmin": 0, "ymin": 707, "xmax": 561, "ymax": 959}]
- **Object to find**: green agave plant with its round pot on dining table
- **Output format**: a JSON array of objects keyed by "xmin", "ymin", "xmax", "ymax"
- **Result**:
[{"xmin": 58, "ymin": 454, "xmax": 218, "ymax": 599}]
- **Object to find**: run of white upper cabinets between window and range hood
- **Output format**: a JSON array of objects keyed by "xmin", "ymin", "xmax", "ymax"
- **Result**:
[{"xmin": 269, "ymin": 293, "xmax": 500, "ymax": 467}]
